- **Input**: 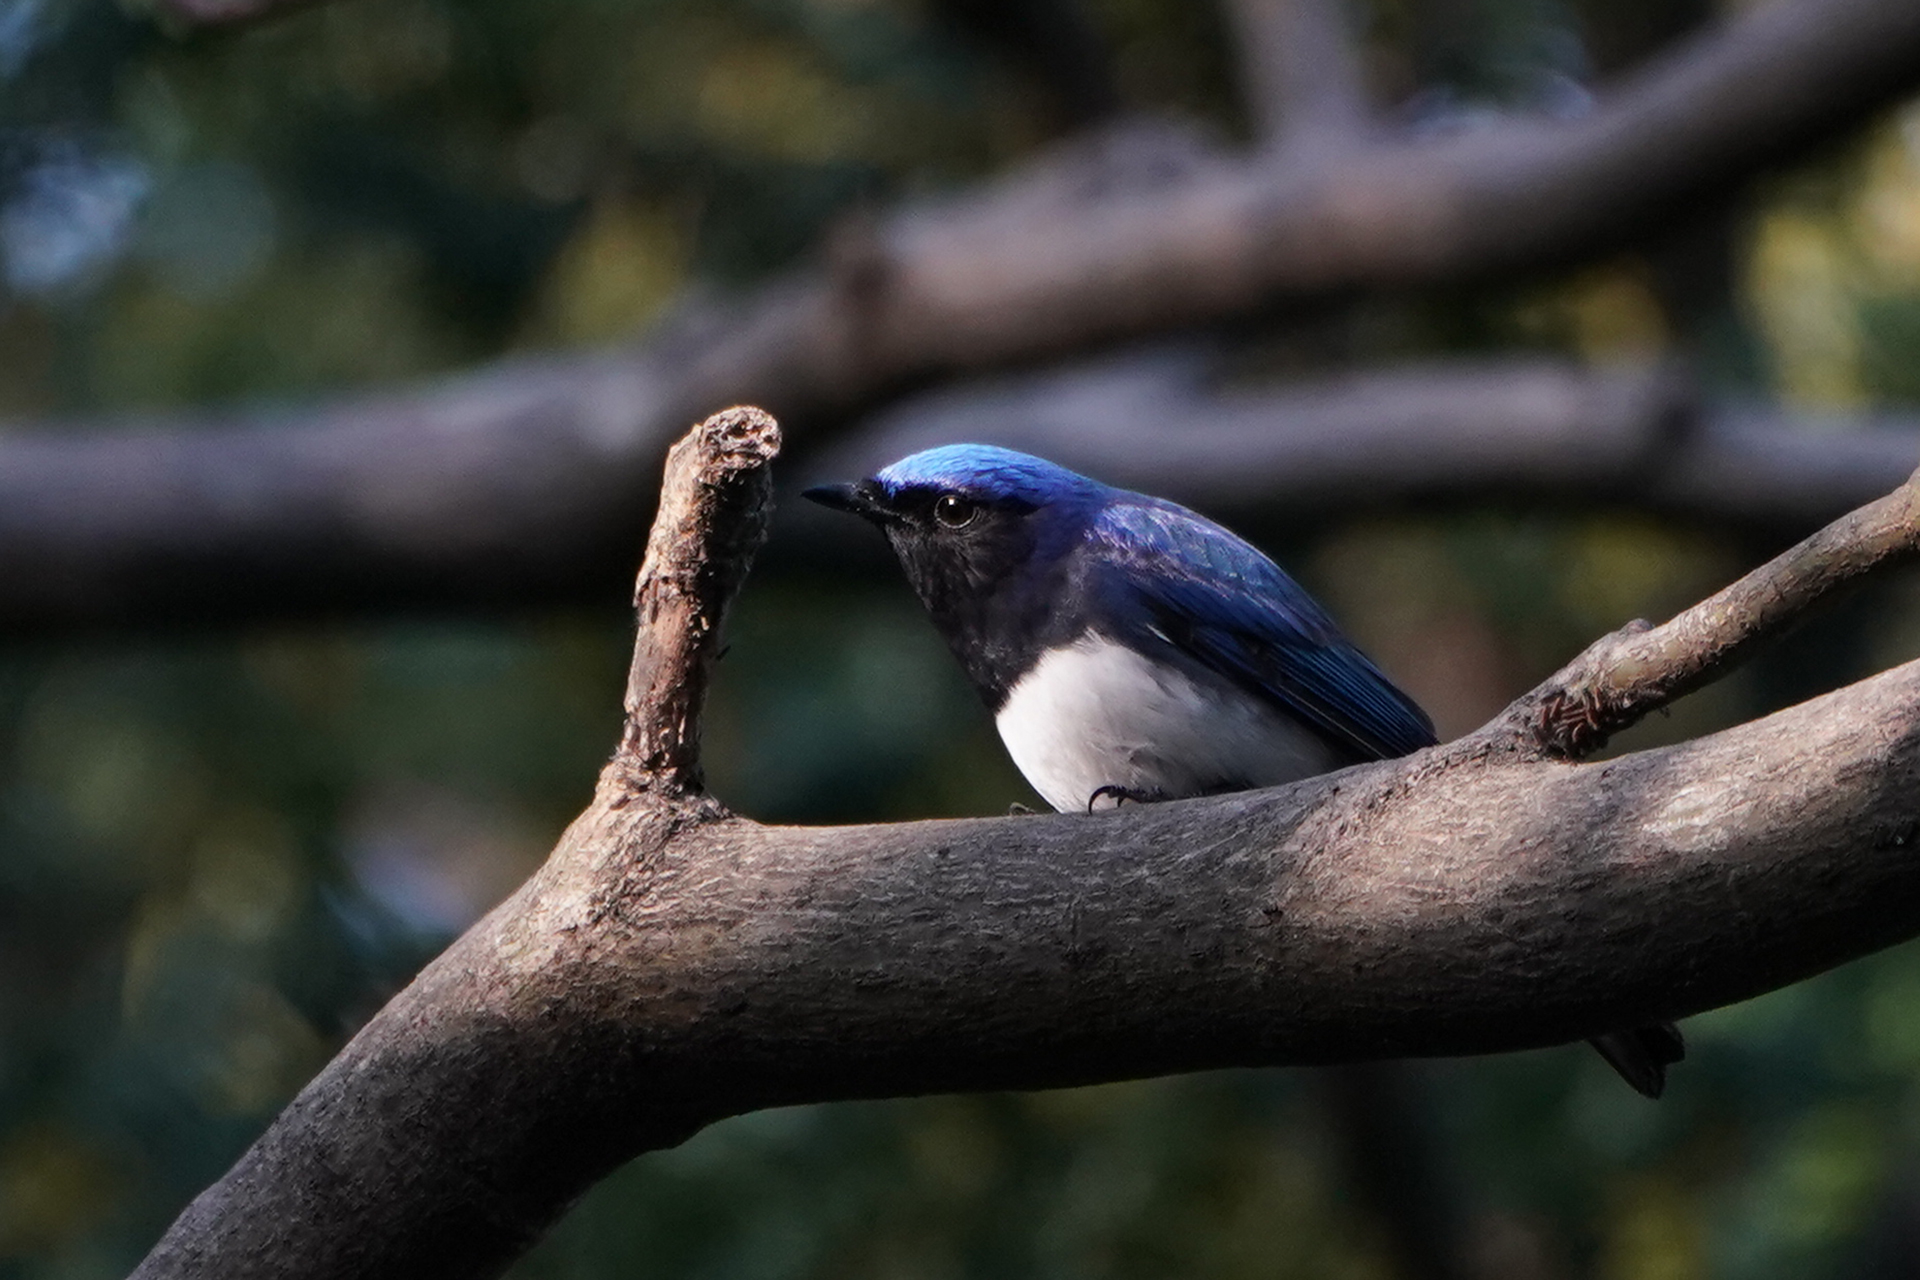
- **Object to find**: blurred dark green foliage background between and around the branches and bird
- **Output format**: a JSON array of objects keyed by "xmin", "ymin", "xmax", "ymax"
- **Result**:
[{"xmin": 0, "ymin": 0, "xmax": 1920, "ymax": 1280}]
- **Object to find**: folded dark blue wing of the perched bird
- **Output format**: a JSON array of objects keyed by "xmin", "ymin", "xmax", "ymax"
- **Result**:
[{"xmin": 1087, "ymin": 495, "xmax": 1436, "ymax": 760}]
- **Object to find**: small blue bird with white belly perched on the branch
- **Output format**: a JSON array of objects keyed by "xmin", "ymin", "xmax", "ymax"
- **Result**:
[{"xmin": 803, "ymin": 443, "xmax": 1686, "ymax": 1098}]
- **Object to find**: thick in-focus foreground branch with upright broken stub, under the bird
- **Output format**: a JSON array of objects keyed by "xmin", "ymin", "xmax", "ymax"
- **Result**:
[{"xmin": 138, "ymin": 416, "xmax": 1920, "ymax": 1278}]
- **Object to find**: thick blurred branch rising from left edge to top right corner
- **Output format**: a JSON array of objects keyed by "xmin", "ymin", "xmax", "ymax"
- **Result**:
[{"xmin": 0, "ymin": 0, "xmax": 1920, "ymax": 635}]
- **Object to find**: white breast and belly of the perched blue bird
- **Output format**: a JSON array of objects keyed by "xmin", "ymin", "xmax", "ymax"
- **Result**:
[{"xmin": 995, "ymin": 635, "xmax": 1338, "ymax": 812}]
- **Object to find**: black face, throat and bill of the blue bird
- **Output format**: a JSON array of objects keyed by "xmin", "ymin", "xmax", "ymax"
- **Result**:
[{"xmin": 804, "ymin": 480, "xmax": 1064, "ymax": 704}]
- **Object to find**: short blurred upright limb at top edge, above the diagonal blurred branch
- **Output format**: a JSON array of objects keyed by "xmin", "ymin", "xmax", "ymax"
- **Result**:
[{"xmin": 1227, "ymin": 0, "xmax": 1369, "ymax": 148}]
